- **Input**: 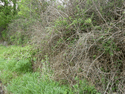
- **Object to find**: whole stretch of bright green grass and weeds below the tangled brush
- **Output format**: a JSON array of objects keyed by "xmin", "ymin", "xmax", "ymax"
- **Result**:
[{"xmin": 0, "ymin": 45, "xmax": 98, "ymax": 94}]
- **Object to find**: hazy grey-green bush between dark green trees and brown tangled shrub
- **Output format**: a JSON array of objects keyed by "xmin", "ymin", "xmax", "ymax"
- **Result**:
[{"xmin": 7, "ymin": 0, "xmax": 44, "ymax": 45}]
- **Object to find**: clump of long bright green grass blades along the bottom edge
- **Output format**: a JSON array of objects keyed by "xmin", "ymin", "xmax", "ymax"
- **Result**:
[{"xmin": 7, "ymin": 73, "xmax": 73, "ymax": 94}]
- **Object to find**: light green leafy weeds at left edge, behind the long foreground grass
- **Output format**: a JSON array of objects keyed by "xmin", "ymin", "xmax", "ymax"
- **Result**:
[{"xmin": 0, "ymin": 46, "xmax": 32, "ymax": 84}]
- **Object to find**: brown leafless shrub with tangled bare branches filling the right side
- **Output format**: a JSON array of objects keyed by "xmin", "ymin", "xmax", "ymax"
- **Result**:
[{"xmin": 43, "ymin": 0, "xmax": 125, "ymax": 94}]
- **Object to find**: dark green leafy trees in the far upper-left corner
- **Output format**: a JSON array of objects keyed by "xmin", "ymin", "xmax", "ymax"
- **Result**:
[{"xmin": 0, "ymin": 0, "xmax": 17, "ymax": 40}]
